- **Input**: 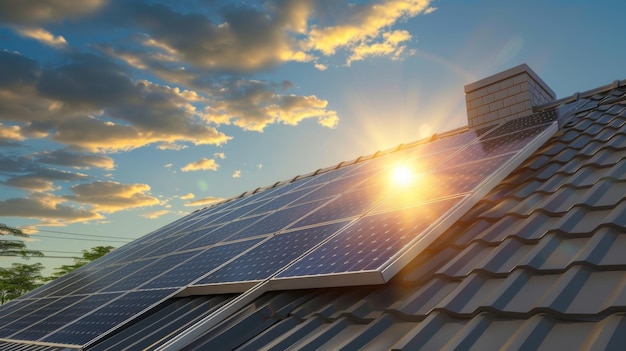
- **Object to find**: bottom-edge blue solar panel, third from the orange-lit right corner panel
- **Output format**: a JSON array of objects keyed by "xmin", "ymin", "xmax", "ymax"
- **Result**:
[{"xmin": 141, "ymin": 239, "xmax": 261, "ymax": 289}]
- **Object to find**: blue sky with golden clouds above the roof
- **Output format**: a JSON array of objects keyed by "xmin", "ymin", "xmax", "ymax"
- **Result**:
[{"xmin": 0, "ymin": 0, "xmax": 626, "ymax": 272}]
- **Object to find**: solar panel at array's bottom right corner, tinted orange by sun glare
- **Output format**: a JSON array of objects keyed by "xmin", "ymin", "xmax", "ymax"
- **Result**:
[{"xmin": 278, "ymin": 199, "xmax": 458, "ymax": 277}]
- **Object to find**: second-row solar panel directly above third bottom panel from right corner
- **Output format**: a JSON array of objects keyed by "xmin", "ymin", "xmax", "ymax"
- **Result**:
[{"xmin": 228, "ymin": 200, "xmax": 324, "ymax": 240}]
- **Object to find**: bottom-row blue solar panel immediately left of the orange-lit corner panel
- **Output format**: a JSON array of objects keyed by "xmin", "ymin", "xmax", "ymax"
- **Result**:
[{"xmin": 195, "ymin": 222, "xmax": 348, "ymax": 285}]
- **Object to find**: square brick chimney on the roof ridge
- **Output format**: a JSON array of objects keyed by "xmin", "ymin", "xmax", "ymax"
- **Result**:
[{"xmin": 465, "ymin": 64, "xmax": 556, "ymax": 128}]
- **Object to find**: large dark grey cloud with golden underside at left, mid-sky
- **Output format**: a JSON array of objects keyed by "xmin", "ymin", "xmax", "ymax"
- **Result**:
[{"xmin": 0, "ymin": 52, "xmax": 230, "ymax": 152}]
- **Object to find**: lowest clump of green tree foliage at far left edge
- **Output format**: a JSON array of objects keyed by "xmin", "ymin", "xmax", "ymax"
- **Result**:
[{"xmin": 0, "ymin": 263, "xmax": 44, "ymax": 304}]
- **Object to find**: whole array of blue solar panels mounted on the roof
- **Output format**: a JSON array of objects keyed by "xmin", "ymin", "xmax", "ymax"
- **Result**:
[{"xmin": 0, "ymin": 118, "xmax": 556, "ymax": 347}]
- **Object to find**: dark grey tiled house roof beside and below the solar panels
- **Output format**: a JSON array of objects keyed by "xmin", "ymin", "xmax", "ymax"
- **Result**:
[{"xmin": 0, "ymin": 67, "xmax": 626, "ymax": 350}]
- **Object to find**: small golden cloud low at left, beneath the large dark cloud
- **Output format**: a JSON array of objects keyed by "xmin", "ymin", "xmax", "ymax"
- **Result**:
[{"xmin": 64, "ymin": 181, "xmax": 160, "ymax": 213}]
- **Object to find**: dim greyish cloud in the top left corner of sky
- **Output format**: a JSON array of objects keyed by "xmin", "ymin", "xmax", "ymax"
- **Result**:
[{"xmin": 0, "ymin": 0, "xmax": 107, "ymax": 24}]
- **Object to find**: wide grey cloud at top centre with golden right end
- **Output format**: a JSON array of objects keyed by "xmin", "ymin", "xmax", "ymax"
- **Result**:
[{"xmin": 109, "ymin": 0, "xmax": 434, "ymax": 73}]
